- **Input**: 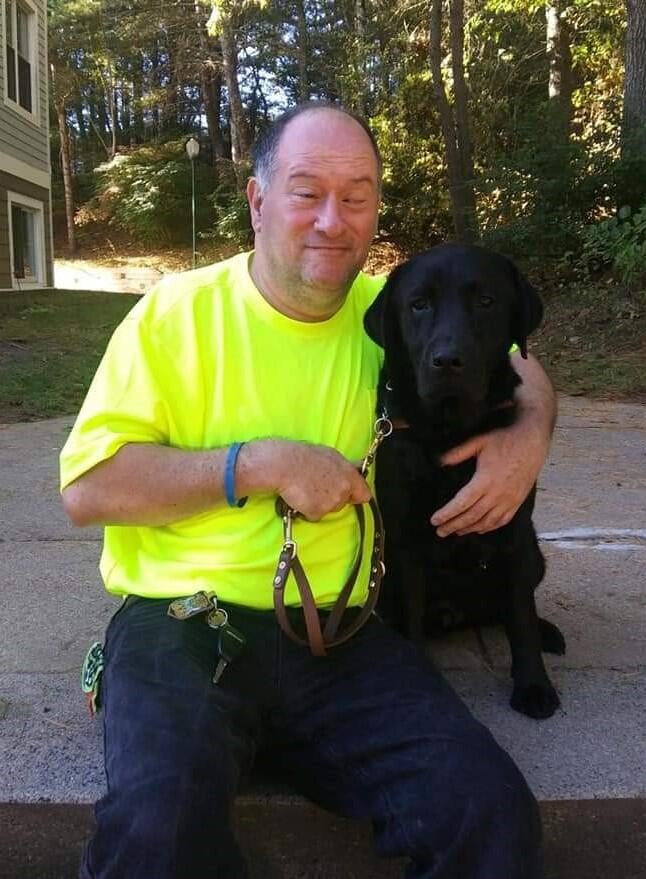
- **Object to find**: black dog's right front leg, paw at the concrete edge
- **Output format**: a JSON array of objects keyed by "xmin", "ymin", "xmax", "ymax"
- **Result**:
[{"xmin": 505, "ymin": 537, "xmax": 560, "ymax": 719}]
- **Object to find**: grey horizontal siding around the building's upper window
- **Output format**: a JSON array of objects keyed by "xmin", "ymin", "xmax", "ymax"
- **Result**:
[{"xmin": 0, "ymin": 0, "xmax": 49, "ymax": 174}]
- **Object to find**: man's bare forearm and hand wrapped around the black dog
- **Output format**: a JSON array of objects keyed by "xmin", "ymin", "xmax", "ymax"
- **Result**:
[{"xmin": 431, "ymin": 353, "xmax": 556, "ymax": 537}]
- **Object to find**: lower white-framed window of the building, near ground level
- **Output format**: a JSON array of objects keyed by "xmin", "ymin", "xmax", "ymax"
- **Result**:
[{"xmin": 9, "ymin": 192, "xmax": 45, "ymax": 289}]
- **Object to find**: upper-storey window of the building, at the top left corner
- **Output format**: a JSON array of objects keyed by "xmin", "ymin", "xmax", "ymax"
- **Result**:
[{"xmin": 5, "ymin": 0, "xmax": 36, "ymax": 113}]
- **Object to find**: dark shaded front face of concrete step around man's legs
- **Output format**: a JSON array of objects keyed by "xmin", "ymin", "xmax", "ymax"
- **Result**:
[{"xmin": 0, "ymin": 796, "xmax": 646, "ymax": 879}]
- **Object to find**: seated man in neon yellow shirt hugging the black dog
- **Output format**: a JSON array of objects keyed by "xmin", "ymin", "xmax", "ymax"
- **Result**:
[{"xmin": 61, "ymin": 104, "xmax": 554, "ymax": 879}]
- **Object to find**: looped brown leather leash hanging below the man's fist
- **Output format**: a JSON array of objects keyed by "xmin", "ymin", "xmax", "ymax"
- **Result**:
[{"xmin": 274, "ymin": 498, "xmax": 385, "ymax": 656}]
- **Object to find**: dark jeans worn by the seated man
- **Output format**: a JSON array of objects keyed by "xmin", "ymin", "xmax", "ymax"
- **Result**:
[{"xmin": 80, "ymin": 599, "xmax": 542, "ymax": 879}]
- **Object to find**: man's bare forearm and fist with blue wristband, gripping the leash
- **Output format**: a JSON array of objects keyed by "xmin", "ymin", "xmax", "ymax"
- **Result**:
[{"xmin": 62, "ymin": 439, "xmax": 371, "ymax": 526}]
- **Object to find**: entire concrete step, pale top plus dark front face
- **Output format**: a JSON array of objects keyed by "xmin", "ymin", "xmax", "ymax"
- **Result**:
[{"xmin": 0, "ymin": 399, "xmax": 646, "ymax": 879}]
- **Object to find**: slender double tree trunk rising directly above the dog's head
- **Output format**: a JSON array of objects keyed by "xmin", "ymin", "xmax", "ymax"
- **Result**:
[{"xmin": 429, "ymin": 0, "xmax": 477, "ymax": 242}]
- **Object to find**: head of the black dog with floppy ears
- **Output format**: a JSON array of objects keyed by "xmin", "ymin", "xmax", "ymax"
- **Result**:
[{"xmin": 364, "ymin": 244, "xmax": 543, "ymax": 420}]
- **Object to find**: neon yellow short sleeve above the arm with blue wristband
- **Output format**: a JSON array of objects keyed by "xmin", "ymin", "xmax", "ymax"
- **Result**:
[{"xmin": 60, "ymin": 308, "xmax": 169, "ymax": 491}]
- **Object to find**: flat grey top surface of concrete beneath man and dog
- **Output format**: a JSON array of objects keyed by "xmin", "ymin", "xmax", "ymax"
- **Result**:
[{"xmin": 0, "ymin": 398, "xmax": 646, "ymax": 879}]
